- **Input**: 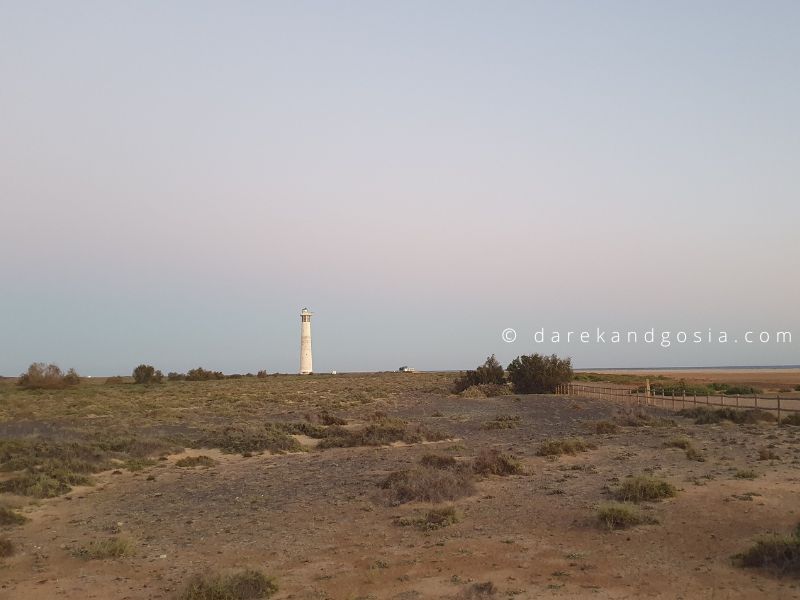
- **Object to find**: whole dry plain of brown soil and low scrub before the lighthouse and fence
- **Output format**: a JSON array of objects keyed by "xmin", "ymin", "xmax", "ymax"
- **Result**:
[{"xmin": 0, "ymin": 370, "xmax": 800, "ymax": 600}]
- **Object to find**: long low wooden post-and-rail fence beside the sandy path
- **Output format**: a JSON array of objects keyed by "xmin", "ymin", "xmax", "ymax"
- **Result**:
[{"xmin": 556, "ymin": 383, "xmax": 800, "ymax": 422}]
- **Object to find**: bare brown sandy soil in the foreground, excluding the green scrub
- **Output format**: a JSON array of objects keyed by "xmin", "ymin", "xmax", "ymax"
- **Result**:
[{"xmin": 0, "ymin": 394, "xmax": 800, "ymax": 600}]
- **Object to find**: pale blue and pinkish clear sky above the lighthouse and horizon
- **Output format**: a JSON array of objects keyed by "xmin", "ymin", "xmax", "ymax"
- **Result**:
[{"xmin": 0, "ymin": 0, "xmax": 800, "ymax": 375}]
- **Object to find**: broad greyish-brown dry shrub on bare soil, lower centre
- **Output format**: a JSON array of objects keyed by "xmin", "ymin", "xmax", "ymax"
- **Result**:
[{"xmin": 380, "ymin": 466, "xmax": 475, "ymax": 504}]
